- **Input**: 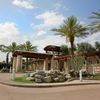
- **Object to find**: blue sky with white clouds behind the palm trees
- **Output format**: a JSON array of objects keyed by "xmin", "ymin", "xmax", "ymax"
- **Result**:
[{"xmin": 0, "ymin": 0, "xmax": 100, "ymax": 61}]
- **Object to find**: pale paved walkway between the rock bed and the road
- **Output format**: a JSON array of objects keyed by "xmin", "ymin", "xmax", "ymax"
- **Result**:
[{"xmin": 0, "ymin": 73, "xmax": 100, "ymax": 87}]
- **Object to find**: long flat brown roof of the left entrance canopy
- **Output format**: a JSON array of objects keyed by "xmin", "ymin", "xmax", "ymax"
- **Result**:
[{"xmin": 13, "ymin": 50, "xmax": 53, "ymax": 59}]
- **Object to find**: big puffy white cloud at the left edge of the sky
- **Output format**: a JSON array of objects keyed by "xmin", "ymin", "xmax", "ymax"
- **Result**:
[{"xmin": 0, "ymin": 22, "xmax": 20, "ymax": 45}]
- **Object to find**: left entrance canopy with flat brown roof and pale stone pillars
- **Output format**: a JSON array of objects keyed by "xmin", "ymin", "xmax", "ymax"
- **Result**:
[{"xmin": 13, "ymin": 51, "xmax": 53, "ymax": 72}]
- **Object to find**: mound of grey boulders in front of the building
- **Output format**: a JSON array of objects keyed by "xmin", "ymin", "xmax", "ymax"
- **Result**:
[{"xmin": 26, "ymin": 70, "xmax": 71, "ymax": 83}]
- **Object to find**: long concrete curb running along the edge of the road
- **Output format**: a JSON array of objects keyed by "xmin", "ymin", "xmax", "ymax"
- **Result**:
[{"xmin": 0, "ymin": 81, "xmax": 100, "ymax": 88}]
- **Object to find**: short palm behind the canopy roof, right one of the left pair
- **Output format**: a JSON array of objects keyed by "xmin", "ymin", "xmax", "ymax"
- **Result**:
[{"xmin": 19, "ymin": 41, "xmax": 37, "ymax": 69}]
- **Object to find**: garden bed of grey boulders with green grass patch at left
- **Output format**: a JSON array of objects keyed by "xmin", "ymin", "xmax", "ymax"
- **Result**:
[{"xmin": 15, "ymin": 70, "xmax": 71, "ymax": 83}]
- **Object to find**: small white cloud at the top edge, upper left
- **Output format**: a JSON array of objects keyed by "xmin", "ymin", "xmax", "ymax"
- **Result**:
[{"xmin": 12, "ymin": 0, "xmax": 35, "ymax": 9}]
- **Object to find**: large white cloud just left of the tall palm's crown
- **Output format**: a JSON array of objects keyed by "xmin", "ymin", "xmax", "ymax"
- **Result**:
[{"xmin": 35, "ymin": 11, "xmax": 65, "ymax": 30}]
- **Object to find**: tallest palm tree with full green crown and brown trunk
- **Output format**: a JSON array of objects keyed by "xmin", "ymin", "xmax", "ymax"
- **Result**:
[{"xmin": 52, "ymin": 16, "xmax": 88, "ymax": 55}]
